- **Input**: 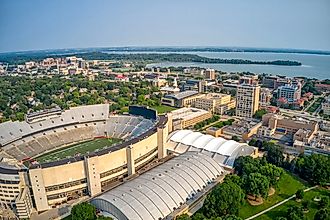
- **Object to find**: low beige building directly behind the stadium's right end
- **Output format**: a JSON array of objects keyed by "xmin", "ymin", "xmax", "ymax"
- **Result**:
[{"xmin": 171, "ymin": 108, "xmax": 212, "ymax": 130}]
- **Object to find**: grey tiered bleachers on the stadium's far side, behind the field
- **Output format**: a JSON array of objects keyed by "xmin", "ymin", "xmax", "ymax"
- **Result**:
[{"xmin": 0, "ymin": 105, "xmax": 155, "ymax": 160}]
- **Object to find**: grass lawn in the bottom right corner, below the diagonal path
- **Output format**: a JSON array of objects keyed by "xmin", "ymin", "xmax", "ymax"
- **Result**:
[{"xmin": 256, "ymin": 188, "xmax": 330, "ymax": 220}]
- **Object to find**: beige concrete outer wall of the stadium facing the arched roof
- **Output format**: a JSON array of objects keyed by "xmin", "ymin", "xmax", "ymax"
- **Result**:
[{"xmin": 29, "ymin": 129, "xmax": 161, "ymax": 211}]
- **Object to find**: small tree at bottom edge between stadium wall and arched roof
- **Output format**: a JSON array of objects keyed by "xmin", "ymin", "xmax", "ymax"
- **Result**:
[{"xmin": 71, "ymin": 202, "xmax": 96, "ymax": 220}]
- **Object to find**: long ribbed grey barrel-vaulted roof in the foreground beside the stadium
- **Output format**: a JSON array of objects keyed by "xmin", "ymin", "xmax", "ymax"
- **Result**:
[{"xmin": 92, "ymin": 152, "xmax": 224, "ymax": 220}]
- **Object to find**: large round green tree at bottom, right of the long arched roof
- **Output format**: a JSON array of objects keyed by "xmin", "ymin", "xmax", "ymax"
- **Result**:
[{"xmin": 203, "ymin": 182, "xmax": 245, "ymax": 218}]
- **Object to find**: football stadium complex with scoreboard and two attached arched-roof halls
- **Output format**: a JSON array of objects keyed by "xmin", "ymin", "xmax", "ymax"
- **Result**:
[{"xmin": 0, "ymin": 104, "xmax": 255, "ymax": 220}]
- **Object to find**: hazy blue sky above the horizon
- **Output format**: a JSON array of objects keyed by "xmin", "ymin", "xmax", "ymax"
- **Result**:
[{"xmin": 0, "ymin": 0, "xmax": 330, "ymax": 52}]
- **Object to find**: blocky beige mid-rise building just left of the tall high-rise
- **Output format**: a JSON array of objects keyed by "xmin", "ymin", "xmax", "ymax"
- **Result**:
[{"xmin": 195, "ymin": 93, "xmax": 236, "ymax": 115}]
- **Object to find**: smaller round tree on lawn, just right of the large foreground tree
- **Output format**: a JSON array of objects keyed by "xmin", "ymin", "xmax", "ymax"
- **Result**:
[{"xmin": 243, "ymin": 173, "xmax": 269, "ymax": 199}]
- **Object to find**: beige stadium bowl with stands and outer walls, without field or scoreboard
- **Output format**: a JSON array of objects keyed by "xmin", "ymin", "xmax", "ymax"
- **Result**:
[{"xmin": 0, "ymin": 105, "xmax": 172, "ymax": 218}]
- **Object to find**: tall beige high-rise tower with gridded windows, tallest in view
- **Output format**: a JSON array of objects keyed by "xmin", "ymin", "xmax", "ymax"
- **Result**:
[{"xmin": 236, "ymin": 84, "xmax": 260, "ymax": 118}]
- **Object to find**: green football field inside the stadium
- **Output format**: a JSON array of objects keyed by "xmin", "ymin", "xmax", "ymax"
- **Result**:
[{"xmin": 35, "ymin": 138, "xmax": 121, "ymax": 163}]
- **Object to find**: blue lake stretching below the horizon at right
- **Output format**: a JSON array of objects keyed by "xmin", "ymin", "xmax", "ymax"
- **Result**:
[{"xmin": 143, "ymin": 52, "xmax": 330, "ymax": 79}]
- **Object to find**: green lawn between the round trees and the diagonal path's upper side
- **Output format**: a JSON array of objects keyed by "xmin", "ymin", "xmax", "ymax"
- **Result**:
[{"xmin": 239, "ymin": 172, "xmax": 307, "ymax": 219}]
